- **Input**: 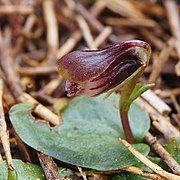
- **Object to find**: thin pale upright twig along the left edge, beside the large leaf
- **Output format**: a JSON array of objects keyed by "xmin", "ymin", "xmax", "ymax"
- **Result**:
[{"xmin": 0, "ymin": 79, "xmax": 14, "ymax": 170}]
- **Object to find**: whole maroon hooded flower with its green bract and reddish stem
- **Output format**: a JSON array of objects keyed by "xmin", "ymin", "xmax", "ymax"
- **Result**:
[{"xmin": 57, "ymin": 40, "xmax": 151, "ymax": 143}]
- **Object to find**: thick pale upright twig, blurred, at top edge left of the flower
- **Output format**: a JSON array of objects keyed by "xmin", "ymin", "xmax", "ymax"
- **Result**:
[{"xmin": 43, "ymin": 0, "xmax": 59, "ymax": 65}]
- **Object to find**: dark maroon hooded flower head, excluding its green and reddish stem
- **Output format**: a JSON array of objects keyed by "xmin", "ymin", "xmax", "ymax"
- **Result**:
[{"xmin": 58, "ymin": 40, "xmax": 151, "ymax": 97}]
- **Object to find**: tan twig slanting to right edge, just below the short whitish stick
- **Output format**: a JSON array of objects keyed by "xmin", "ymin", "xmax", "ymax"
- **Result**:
[{"xmin": 135, "ymin": 98, "xmax": 180, "ymax": 139}]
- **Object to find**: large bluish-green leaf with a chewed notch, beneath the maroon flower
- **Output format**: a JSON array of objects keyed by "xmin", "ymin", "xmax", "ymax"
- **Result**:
[{"xmin": 10, "ymin": 95, "xmax": 150, "ymax": 170}]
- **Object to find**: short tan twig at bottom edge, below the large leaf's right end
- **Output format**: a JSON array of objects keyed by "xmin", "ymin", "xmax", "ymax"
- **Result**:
[{"xmin": 122, "ymin": 166, "xmax": 165, "ymax": 180}]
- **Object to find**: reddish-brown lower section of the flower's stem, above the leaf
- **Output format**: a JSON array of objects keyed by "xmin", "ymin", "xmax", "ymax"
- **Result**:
[{"xmin": 120, "ymin": 111, "xmax": 136, "ymax": 143}]
